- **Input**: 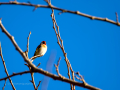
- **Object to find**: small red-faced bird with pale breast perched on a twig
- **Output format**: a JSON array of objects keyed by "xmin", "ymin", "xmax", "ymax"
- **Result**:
[{"xmin": 32, "ymin": 41, "xmax": 47, "ymax": 62}]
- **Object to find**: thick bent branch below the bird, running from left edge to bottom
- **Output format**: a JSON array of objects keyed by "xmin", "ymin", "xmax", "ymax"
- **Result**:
[{"xmin": 0, "ymin": 20, "xmax": 101, "ymax": 90}]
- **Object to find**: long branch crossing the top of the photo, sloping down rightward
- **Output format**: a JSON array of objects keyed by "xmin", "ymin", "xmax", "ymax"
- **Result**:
[{"xmin": 0, "ymin": 1, "xmax": 120, "ymax": 26}]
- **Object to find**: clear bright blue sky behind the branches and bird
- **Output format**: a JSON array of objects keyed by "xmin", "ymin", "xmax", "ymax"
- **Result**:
[{"xmin": 0, "ymin": 0, "xmax": 120, "ymax": 90}]
